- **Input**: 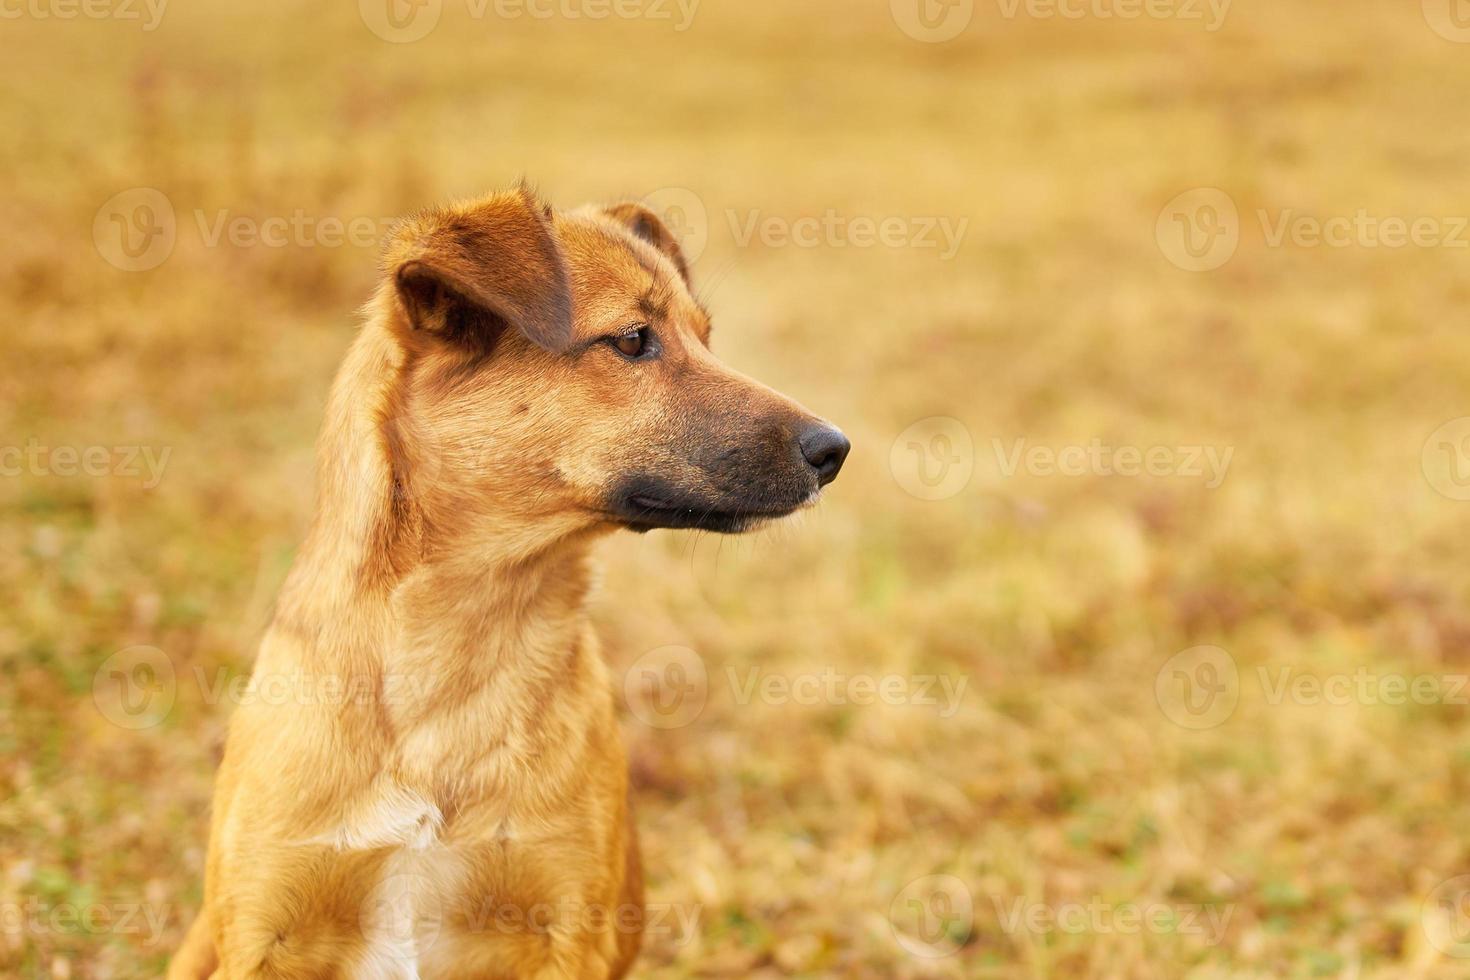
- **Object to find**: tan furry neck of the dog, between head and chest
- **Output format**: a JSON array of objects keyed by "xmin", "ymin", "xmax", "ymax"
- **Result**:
[{"xmin": 276, "ymin": 314, "xmax": 600, "ymax": 701}]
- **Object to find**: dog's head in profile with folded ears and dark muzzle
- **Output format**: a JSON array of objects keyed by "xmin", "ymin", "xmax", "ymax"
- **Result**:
[{"xmin": 381, "ymin": 188, "xmax": 848, "ymax": 533}]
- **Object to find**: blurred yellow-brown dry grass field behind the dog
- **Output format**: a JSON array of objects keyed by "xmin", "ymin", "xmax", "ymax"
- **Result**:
[{"xmin": 0, "ymin": 0, "xmax": 1470, "ymax": 980}]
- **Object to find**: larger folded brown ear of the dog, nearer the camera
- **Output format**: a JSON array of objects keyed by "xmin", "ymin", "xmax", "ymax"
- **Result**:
[{"xmin": 388, "ymin": 187, "xmax": 572, "ymax": 353}]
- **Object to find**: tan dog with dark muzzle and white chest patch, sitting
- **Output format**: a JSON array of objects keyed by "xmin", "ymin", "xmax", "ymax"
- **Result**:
[{"xmin": 169, "ymin": 188, "xmax": 848, "ymax": 980}]
